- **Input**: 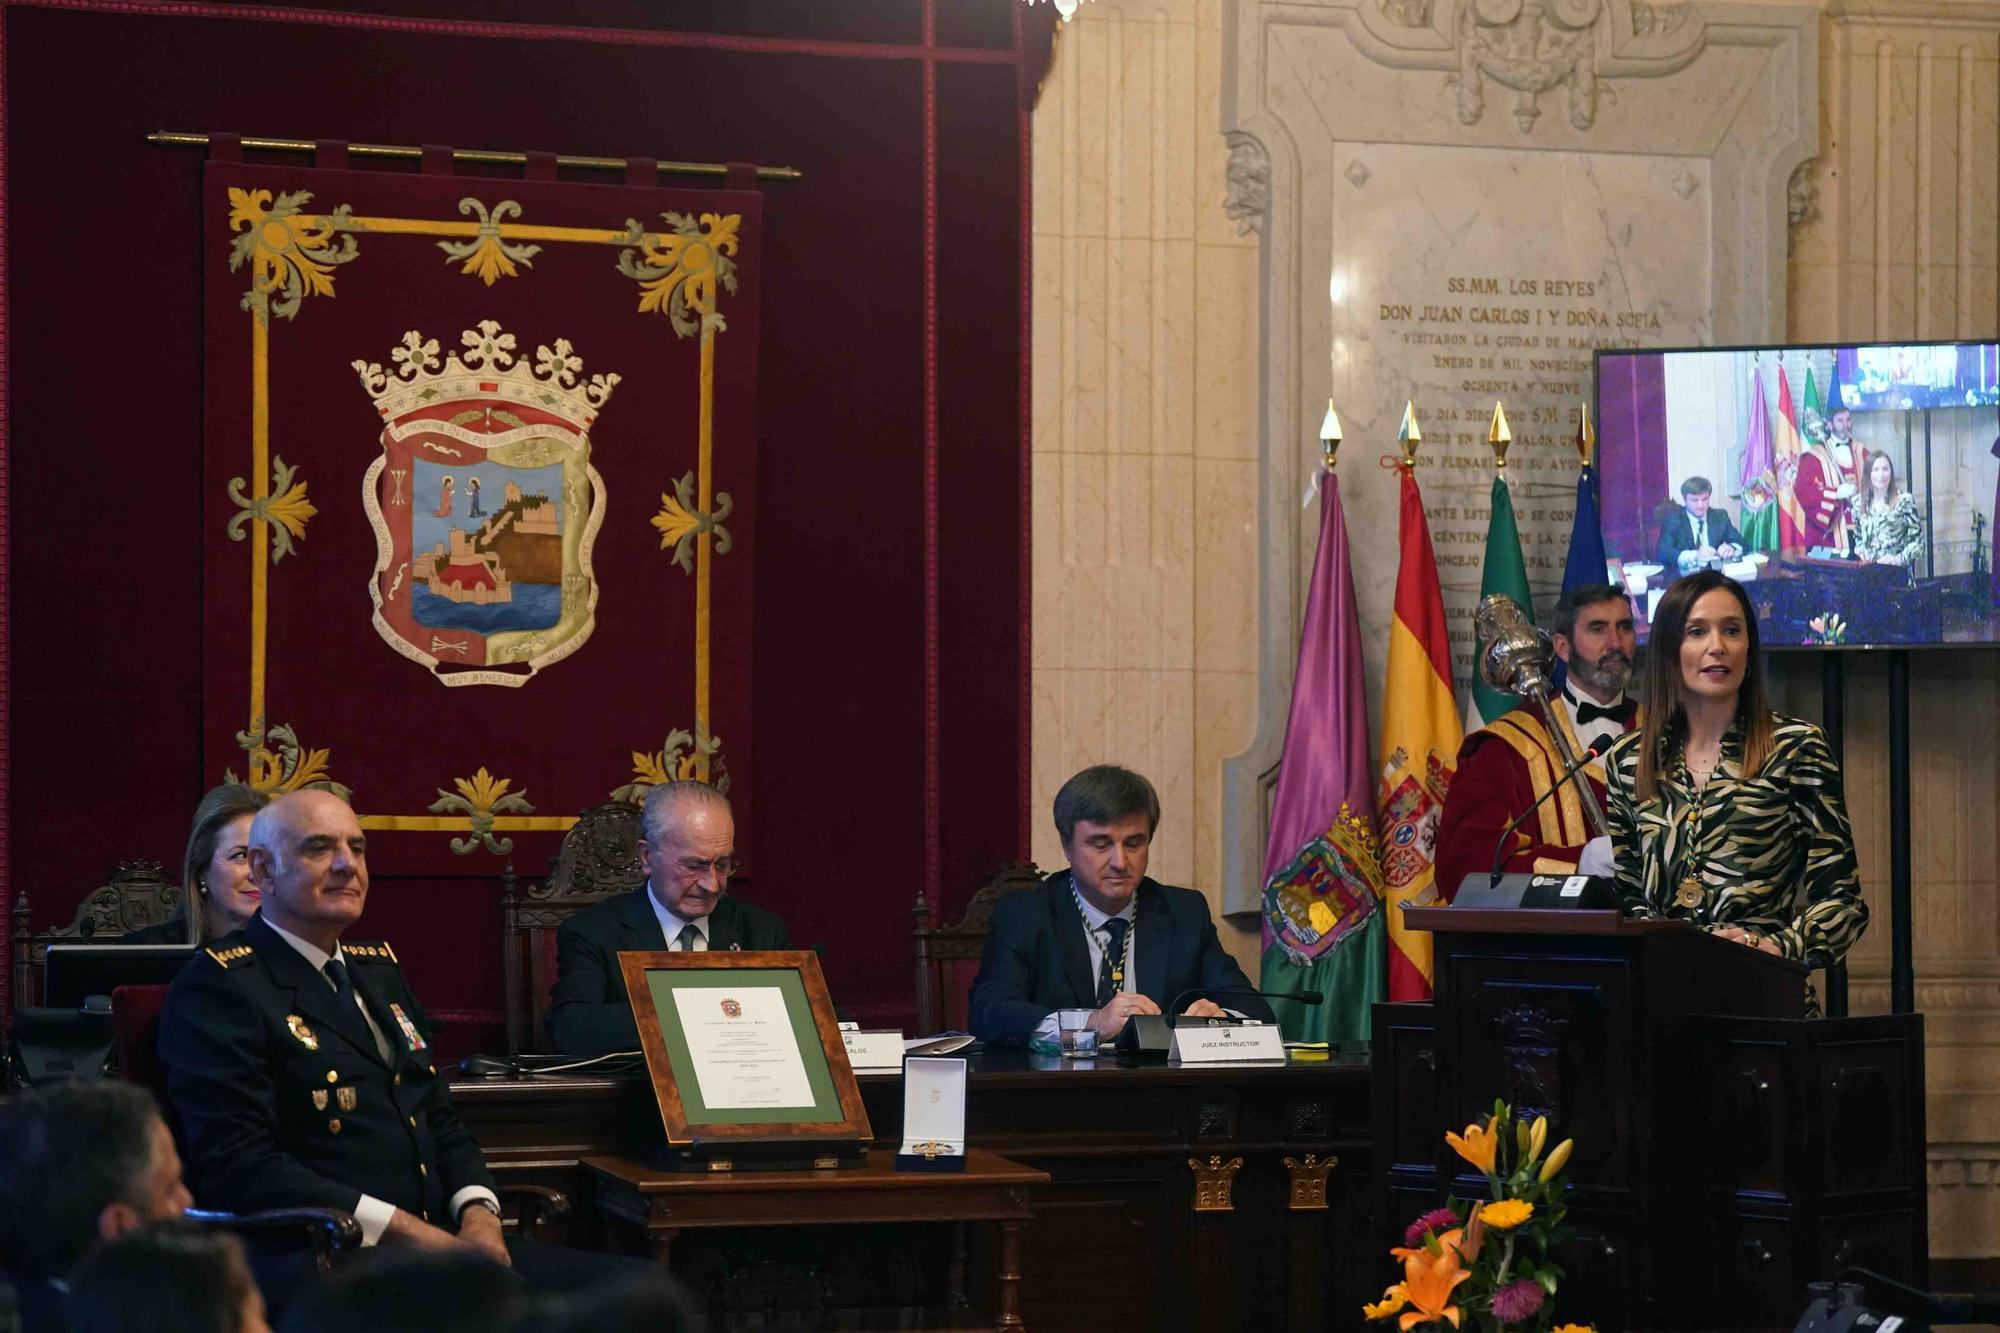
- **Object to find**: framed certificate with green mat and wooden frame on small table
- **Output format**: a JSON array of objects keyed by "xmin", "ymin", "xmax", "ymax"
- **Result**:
[{"xmin": 618, "ymin": 949, "xmax": 870, "ymax": 1171}]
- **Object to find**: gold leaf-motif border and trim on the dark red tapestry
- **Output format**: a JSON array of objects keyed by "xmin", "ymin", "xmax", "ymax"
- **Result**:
[{"xmin": 219, "ymin": 174, "xmax": 748, "ymax": 855}]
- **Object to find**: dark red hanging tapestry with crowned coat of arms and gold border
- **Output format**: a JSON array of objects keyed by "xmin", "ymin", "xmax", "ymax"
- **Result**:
[{"xmin": 203, "ymin": 162, "xmax": 760, "ymax": 875}]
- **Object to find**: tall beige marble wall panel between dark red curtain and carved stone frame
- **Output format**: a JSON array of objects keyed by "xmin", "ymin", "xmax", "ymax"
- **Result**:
[{"xmin": 1032, "ymin": 0, "xmax": 1258, "ymax": 961}]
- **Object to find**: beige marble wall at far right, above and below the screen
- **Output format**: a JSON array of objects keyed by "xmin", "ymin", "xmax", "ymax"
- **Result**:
[{"xmin": 1786, "ymin": 0, "xmax": 2000, "ymax": 1257}]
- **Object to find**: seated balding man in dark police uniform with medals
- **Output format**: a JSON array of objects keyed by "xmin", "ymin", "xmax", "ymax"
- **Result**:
[{"xmin": 160, "ymin": 791, "xmax": 632, "ymax": 1295}]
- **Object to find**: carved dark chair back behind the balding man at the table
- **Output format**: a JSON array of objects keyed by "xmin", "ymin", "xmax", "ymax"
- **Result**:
[{"xmin": 500, "ymin": 801, "xmax": 646, "ymax": 1055}]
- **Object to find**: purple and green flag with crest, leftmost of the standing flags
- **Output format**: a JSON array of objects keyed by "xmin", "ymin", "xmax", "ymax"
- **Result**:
[{"xmin": 1258, "ymin": 426, "xmax": 1388, "ymax": 1043}]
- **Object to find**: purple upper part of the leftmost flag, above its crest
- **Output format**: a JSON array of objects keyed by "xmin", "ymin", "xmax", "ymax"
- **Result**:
[{"xmin": 1264, "ymin": 472, "xmax": 1374, "ymax": 883}]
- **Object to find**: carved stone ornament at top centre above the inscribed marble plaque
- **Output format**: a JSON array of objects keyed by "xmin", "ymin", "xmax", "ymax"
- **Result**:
[{"xmin": 1362, "ymin": 0, "xmax": 1706, "ymax": 134}]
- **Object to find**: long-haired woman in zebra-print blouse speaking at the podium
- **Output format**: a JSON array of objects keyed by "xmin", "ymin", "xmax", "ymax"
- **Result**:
[{"xmin": 1606, "ymin": 568, "xmax": 1868, "ymax": 1013}]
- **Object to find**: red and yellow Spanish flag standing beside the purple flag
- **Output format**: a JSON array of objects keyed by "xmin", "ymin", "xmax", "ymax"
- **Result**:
[{"xmin": 1376, "ymin": 452, "xmax": 1464, "ymax": 1001}]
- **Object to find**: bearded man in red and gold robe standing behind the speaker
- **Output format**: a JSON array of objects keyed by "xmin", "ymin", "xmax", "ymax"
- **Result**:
[{"xmin": 1438, "ymin": 582, "xmax": 1638, "ymax": 899}]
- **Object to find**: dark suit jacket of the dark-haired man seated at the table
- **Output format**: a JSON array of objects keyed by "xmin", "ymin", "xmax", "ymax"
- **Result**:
[{"xmin": 972, "ymin": 871, "xmax": 1272, "ymax": 1045}]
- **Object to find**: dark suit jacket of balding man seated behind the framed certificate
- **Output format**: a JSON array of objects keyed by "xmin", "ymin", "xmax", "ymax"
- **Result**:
[{"xmin": 548, "ymin": 887, "xmax": 792, "ymax": 1055}]
